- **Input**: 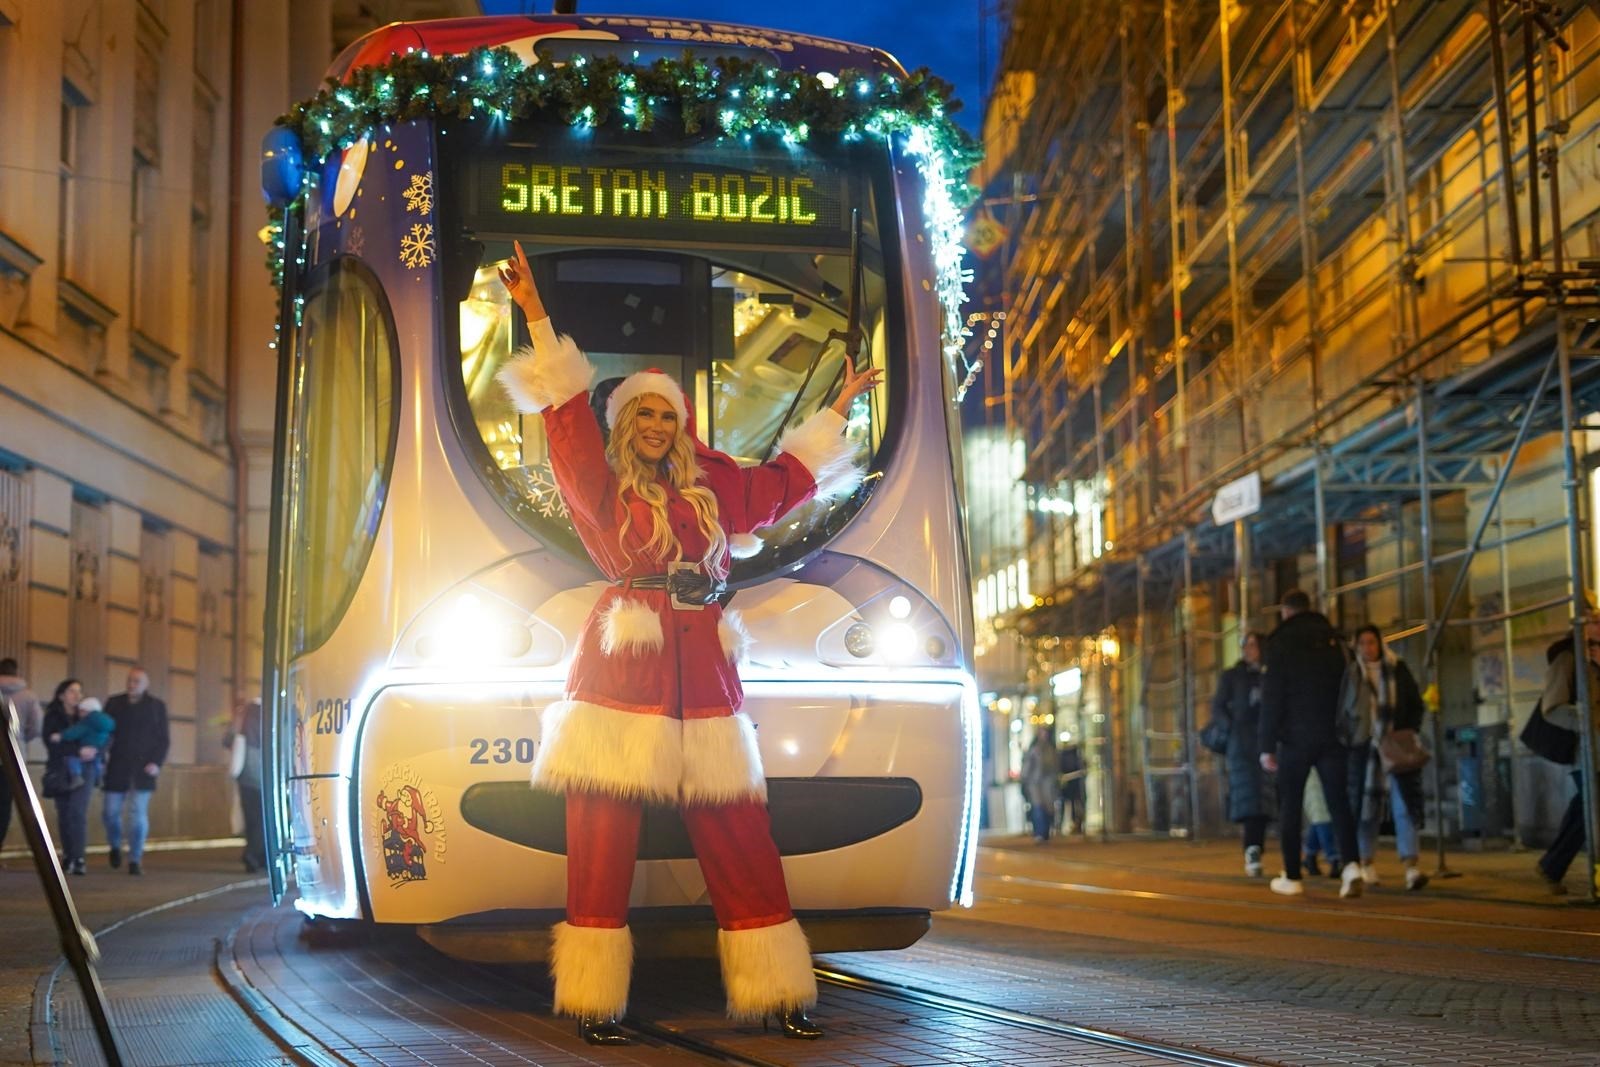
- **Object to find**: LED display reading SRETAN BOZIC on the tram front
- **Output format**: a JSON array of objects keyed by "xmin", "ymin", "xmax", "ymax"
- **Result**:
[{"xmin": 467, "ymin": 154, "xmax": 850, "ymax": 245}]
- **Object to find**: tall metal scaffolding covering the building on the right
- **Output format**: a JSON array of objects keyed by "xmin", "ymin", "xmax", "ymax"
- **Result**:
[{"xmin": 989, "ymin": 0, "xmax": 1600, "ymax": 885}]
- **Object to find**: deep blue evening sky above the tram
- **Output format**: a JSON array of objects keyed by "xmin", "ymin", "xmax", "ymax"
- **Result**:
[{"xmin": 482, "ymin": 0, "xmax": 994, "ymax": 133}]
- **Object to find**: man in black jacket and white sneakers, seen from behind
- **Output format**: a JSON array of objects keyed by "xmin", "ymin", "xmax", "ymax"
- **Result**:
[{"xmin": 1261, "ymin": 589, "xmax": 1362, "ymax": 897}]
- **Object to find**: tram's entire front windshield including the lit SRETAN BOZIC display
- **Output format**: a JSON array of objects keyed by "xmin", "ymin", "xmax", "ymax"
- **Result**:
[{"xmin": 446, "ymin": 130, "xmax": 899, "ymax": 581}]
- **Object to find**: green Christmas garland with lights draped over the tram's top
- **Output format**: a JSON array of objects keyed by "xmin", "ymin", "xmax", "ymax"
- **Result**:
[{"xmin": 267, "ymin": 48, "xmax": 982, "ymax": 367}]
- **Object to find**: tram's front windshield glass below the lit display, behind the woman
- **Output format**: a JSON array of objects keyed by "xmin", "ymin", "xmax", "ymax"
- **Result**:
[{"xmin": 459, "ymin": 246, "xmax": 890, "ymax": 579}]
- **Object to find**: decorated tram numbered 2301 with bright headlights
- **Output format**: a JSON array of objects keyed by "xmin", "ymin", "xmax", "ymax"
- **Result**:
[{"xmin": 266, "ymin": 16, "xmax": 979, "ymax": 958}]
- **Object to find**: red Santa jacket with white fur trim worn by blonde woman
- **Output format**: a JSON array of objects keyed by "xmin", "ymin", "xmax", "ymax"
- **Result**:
[{"xmin": 501, "ymin": 320, "xmax": 853, "ymax": 805}]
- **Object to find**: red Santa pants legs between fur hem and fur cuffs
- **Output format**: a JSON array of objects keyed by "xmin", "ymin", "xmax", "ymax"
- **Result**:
[{"xmin": 566, "ymin": 792, "xmax": 792, "ymax": 929}]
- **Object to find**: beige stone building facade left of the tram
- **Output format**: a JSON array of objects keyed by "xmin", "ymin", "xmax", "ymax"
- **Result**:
[{"xmin": 0, "ymin": 0, "xmax": 478, "ymax": 835}]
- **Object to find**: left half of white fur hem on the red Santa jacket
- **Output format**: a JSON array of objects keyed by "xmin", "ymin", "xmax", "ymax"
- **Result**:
[{"xmin": 533, "ymin": 701, "xmax": 683, "ymax": 805}]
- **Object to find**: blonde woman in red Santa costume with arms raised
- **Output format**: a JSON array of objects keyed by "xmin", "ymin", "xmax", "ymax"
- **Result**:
[{"xmin": 499, "ymin": 245, "xmax": 878, "ymax": 1045}]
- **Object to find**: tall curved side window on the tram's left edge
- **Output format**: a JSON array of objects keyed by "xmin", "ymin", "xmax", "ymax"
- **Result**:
[{"xmin": 286, "ymin": 259, "xmax": 400, "ymax": 656}]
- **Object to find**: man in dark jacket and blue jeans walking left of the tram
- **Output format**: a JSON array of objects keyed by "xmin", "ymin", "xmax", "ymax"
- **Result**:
[{"xmin": 101, "ymin": 665, "xmax": 168, "ymax": 875}]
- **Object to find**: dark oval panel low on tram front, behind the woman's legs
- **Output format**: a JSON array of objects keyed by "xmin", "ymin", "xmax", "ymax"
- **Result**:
[{"xmin": 461, "ymin": 777, "xmax": 922, "ymax": 859}]
